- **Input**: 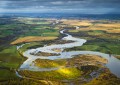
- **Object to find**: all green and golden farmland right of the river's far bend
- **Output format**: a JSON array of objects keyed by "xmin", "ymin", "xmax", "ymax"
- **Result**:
[{"xmin": 66, "ymin": 20, "xmax": 120, "ymax": 55}]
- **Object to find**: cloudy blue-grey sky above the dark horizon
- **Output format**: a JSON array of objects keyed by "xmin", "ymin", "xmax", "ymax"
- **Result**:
[{"xmin": 0, "ymin": 0, "xmax": 120, "ymax": 14}]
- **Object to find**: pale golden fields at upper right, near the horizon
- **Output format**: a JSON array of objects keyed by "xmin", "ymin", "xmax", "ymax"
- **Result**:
[{"xmin": 62, "ymin": 20, "xmax": 120, "ymax": 33}]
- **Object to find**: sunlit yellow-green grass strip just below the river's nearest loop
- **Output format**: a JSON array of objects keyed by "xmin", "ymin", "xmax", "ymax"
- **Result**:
[{"xmin": 19, "ymin": 68, "xmax": 82, "ymax": 80}]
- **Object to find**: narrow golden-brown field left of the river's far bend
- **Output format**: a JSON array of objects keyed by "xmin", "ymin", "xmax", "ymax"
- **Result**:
[{"xmin": 11, "ymin": 36, "xmax": 57, "ymax": 45}]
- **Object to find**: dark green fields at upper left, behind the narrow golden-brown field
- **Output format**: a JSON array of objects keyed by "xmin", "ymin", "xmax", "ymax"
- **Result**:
[{"xmin": 0, "ymin": 21, "xmax": 59, "ymax": 37}]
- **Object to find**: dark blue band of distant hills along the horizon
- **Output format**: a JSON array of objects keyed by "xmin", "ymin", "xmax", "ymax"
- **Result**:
[{"xmin": 0, "ymin": 13, "xmax": 120, "ymax": 20}]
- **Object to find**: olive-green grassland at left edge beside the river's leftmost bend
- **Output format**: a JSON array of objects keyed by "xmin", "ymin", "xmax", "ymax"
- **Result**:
[{"xmin": 0, "ymin": 46, "xmax": 25, "ymax": 81}]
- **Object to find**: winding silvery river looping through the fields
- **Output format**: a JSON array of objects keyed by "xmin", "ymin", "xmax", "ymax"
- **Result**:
[{"xmin": 17, "ymin": 30, "xmax": 120, "ymax": 77}]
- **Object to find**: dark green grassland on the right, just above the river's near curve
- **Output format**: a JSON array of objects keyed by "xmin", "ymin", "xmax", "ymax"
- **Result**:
[{"xmin": 65, "ymin": 42, "xmax": 120, "ymax": 55}]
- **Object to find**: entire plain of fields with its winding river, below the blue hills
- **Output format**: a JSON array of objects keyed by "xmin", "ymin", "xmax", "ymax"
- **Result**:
[{"xmin": 0, "ymin": 17, "xmax": 120, "ymax": 85}]
